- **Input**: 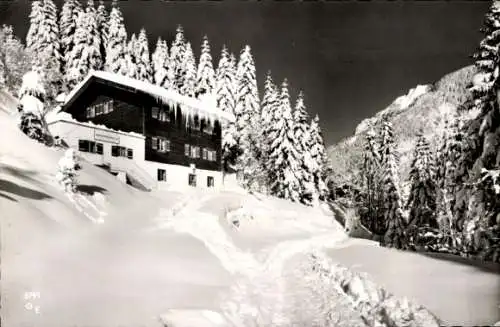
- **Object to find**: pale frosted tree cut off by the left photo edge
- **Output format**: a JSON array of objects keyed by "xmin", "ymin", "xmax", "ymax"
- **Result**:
[{"xmin": 0, "ymin": 25, "xmax": 31, "ymax": 91}]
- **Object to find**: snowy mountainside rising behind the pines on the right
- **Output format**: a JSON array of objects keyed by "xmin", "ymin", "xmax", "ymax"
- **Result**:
[{"xmin": 328, "ymin": 66, "xmax": 476, "ymax": 187}]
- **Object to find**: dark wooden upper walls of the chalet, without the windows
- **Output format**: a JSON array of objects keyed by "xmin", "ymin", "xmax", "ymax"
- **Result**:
[{"xmin": 65, "ymin": 80, "xmax": 222, "ymax": 171}]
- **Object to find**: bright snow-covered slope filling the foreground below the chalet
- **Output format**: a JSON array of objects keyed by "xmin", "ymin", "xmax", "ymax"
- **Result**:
[{"xmin": 0, "ymin": 90, "xmax": 500, "ymax": 327}]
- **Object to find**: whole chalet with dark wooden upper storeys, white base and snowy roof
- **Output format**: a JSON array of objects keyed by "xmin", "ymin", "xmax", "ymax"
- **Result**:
[{"xmin": 49, "ymin": 71, "xmax": 234, "ymax": 190}]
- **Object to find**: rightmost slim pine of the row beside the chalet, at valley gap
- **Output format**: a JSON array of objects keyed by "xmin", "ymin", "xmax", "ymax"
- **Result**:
[{"xmin": 307, "ymin": 115, "xmax": 328, "ymax": 201}]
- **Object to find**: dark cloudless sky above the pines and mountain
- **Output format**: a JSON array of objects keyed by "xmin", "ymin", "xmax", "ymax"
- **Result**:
[{"xmin": 0, "ymin": 0, "xmax": 490, "ymax": 145}]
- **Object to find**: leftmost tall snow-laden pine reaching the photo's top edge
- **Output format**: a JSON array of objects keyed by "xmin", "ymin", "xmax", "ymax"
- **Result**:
[{"xmin": 26, "ymin": 0, "xmax": 61, "ymax": 101}]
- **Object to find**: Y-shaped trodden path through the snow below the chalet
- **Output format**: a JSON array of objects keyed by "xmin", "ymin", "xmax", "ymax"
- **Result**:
[{"xmin": 154, "ymin": 195, "xmax": 347, "ymax": 326}]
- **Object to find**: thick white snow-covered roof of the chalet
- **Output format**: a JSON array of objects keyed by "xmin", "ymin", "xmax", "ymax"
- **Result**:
[{"xmin": 62, "ymin": 71, "xmax": 234, "ymax": 121}]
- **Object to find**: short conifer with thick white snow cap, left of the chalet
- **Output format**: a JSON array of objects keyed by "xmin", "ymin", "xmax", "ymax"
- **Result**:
[{"xmin": 18, "ymin": 71, "xmax": 47, "ymax": 142}]
